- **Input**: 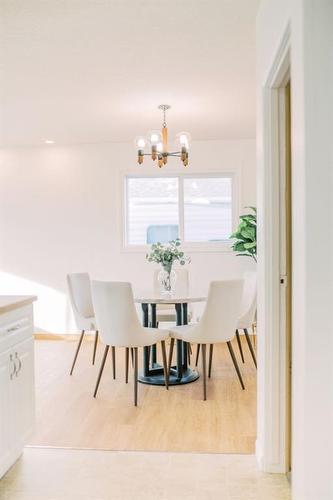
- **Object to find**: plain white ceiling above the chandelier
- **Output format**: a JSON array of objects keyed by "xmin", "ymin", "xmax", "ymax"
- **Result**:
[{"xmin": 0, "ymin": 0, "xmax": 259, "ymax": 145}]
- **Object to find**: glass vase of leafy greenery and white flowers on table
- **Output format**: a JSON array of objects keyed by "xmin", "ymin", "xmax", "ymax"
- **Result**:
[{"xmin": 146, "ymin": 238, "xmax": 191, "ymax": 295}]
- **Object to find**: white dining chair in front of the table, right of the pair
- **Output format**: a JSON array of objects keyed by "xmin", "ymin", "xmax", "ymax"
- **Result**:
[{"xmin": 168, "ymin": 280, "xmax": 245, "ymax": 400}]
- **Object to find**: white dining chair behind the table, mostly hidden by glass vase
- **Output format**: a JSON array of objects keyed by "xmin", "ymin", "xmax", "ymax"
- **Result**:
[{"xmin": 153, "ymin": 268, "xmax": 191, "ymax": 325}]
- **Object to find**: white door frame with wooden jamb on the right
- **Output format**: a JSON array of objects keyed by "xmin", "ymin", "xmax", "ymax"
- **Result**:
[{"xmin": 256, "ymin": 25, "xmax": 292, "ymax": 473}]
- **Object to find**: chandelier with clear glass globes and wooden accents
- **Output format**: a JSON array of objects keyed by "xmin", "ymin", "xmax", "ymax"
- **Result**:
[{"xmin": 135, "ymin": 104, "xmax": 190, "ymax": 168}]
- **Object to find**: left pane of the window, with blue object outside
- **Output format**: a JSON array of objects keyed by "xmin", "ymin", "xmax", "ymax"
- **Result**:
[{"xmin": 127, "ymin": 177, "xmax": 179, "ymax": 245}]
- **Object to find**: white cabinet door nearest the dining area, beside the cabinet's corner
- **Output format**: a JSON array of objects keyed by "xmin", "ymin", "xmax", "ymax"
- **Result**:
[{"xmin": 13, "ymin": 338, "xmax": 35, "ymax": 448}]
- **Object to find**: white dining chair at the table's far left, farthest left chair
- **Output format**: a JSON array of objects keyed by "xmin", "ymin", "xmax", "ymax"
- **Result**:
[{"xmin": 67, "ymin": 273, "xmax": 107, "ymax": 375}]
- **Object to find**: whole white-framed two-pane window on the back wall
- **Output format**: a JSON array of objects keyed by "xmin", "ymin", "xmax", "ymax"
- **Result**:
[{"xmin": 125, "ymin": 174, "xmax": 235, "ymax": 246}]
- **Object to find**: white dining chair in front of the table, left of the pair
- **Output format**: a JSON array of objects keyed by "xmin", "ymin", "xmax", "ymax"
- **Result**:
[{"xmin": 91, "ymin": 281, "xmax": 169, "ymax": 406}]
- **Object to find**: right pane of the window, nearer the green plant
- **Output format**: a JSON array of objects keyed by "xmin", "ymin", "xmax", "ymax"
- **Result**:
[{"xmin": 184, "ymin": 177, "xmax": 232, "ymax": 242}]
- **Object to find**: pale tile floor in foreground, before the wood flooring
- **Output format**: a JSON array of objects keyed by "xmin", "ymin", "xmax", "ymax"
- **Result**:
[{"xmin": 0, "ymin": 448, "xmax": 290, "ymax": 500}]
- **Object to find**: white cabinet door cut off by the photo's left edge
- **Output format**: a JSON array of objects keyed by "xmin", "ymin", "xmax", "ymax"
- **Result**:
[{"xmin": 0, "ymin": 350, "xmax": 15, "ymax": 477}]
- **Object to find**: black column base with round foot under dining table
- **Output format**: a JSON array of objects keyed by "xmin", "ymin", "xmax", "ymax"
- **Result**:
[{"xmin": 138, "ymin": 303, "xmax": 199, "ymax": 385}]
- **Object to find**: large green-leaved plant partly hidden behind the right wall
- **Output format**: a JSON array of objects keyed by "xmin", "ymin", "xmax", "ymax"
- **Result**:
[{"xmin": 230, "ymin": 207, "xmax": 257, "ymax": 262}]
